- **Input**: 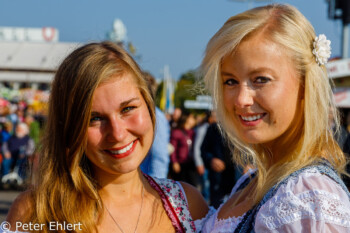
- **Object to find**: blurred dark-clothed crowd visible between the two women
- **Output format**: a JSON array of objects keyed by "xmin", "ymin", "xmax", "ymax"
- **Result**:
[{"xmin": 159, "ymin": 108, "xmax": 243, "ymax": 207}]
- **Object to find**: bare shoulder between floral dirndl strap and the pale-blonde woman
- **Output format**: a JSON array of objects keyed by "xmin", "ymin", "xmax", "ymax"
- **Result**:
[{"xmin": 180, "ymin": 182, "xmax": 209, "ymax": 220}]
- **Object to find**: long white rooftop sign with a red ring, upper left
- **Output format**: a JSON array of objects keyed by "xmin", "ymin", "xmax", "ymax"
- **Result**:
[{"xmin": 0, "ymin": 27, "xmax": 59, "ymax": 42}]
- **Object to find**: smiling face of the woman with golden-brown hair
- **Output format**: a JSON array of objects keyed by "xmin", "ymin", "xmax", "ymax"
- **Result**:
[{"xmin": 85, "ymin": 73, "xmax": 153, "ymax": 175}]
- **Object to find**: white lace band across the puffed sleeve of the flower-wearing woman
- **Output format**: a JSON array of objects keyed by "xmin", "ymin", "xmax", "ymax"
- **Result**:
[{"xmin": 258, "ymin": 190, "xmax": 350, "ymax": 230}]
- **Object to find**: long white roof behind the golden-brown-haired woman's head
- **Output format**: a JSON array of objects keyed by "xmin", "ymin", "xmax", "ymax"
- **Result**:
[{"xmin": 0, "ymin": 42, "xmax": 82, "ymax": 83}]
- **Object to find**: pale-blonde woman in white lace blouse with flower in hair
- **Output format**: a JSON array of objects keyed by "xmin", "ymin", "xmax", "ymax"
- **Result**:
[{"xmin": 202, "ymin": 4, "xmax": 350, "ymax": 232}]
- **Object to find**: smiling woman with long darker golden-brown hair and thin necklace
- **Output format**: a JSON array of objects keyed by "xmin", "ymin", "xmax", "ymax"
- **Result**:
[{"xmin": 3, "ymin": 42, "xmax": 208, "ymax": 232}]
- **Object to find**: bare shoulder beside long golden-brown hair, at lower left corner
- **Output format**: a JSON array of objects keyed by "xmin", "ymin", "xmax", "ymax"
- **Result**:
[{"xmin": 6, "ymin": 190, "xmax": 34, "ymax": 226}]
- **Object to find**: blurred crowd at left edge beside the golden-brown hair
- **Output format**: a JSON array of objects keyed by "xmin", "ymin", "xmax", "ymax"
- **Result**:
[{"xmin": 0, "ymin": 98, "xmax": 45, "ymax": 189}]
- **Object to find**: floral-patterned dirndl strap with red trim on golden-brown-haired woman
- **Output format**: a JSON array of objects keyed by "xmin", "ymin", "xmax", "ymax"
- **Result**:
[{"xmin": 149, "ymin": 177, "xmax": 196, "ymax": 232}]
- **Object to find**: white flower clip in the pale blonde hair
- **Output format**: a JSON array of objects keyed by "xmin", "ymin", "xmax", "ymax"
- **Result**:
[{"xmin": 312, "ymin": 34, "xmax": 331, "ymax": 66}]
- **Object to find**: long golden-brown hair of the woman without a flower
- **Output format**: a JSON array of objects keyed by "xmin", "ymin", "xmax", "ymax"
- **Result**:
[{"xmin": 29, "ymin": 42, "xmax": 155, "ymax": 232}]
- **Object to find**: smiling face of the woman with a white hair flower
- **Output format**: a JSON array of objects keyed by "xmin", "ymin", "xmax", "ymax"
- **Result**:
[{"xmin": 221, "ymin": 34, "xmax": 300, "ymax": 144}]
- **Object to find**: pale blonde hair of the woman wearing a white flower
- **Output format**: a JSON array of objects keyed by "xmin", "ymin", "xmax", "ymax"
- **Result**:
[{"xmin": 201, "ymin": 4, "xmax": 346, "ymax": 202}]
